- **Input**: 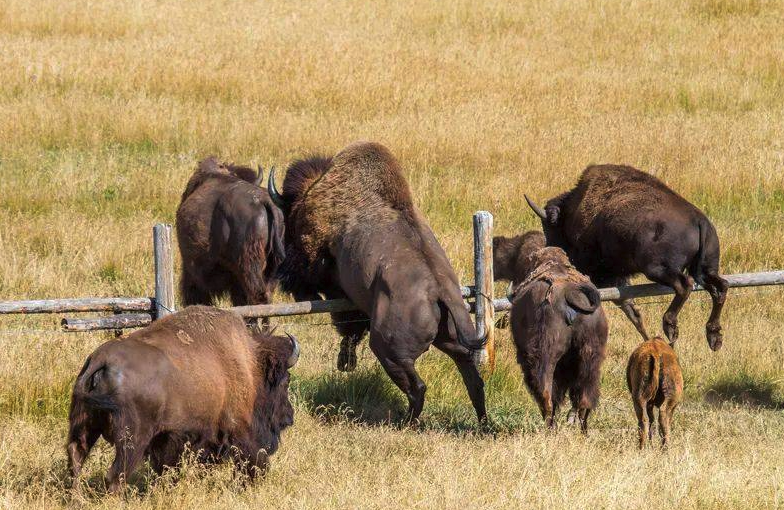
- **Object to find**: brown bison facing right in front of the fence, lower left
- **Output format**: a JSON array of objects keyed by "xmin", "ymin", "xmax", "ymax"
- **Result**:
[{"xmin": 67, "ymin": 306, "xmax": 299, "ymax": 491}]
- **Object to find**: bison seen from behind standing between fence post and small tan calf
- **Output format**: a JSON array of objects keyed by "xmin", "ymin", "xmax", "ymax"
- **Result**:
[{"xmin": 510, "ymin": 247, "xmax": 607, "ymax": 433}]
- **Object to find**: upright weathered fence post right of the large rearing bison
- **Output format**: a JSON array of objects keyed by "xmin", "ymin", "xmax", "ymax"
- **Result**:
[{"xmin": 474, "ymin": 211, "xmax": 495, "ymax": 373}]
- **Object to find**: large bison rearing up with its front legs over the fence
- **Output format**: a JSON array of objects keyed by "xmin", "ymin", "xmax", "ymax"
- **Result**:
[{"xmin": 268, "ymin": 142, "xmax": 485, "ymax": 421}]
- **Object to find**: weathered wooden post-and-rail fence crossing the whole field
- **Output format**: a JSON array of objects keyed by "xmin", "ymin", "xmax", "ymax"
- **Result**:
[{"xmin": 0, "ymin": 211, "xmax": 784, "ymax": 371}]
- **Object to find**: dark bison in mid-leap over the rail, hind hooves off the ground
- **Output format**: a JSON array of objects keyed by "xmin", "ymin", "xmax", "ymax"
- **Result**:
[{"xmin": 525, "ymin": 165, "xmax": 728, "ymax": 351}]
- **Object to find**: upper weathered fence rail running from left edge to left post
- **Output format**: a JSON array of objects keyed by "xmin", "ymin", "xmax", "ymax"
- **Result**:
[{"xmin": 0, "ymin": 297, "xmax": 154, "ymax": 314}]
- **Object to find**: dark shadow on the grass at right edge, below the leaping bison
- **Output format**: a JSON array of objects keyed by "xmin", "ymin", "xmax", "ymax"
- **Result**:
[{"xmin": 705, "ymin": 372, "xmax": 784, "ymax": 410}]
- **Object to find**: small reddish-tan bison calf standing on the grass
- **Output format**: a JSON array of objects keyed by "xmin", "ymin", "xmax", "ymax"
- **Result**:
[{"xmin": 626, "ymin": 337, "xmax": 683, "ymax": 448}]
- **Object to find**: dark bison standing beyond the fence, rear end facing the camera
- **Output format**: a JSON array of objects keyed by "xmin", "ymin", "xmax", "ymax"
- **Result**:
[{"xmin": 177, "ymin": 157, "xmax": 285, "ymax": 312}]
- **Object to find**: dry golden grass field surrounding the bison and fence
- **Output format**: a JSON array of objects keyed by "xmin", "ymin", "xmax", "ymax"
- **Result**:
[{"xmin": 0, "ymin": 0, "xmax": 784, "ymax": 510}]
